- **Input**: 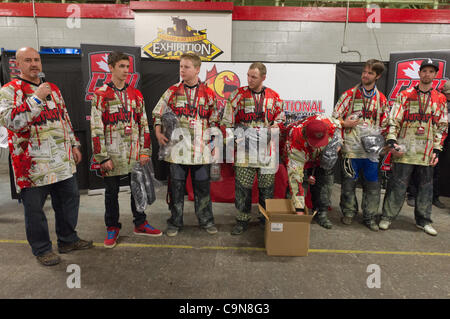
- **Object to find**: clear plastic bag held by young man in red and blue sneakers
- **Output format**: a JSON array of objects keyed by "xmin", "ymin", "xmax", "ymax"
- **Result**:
[{"xmin": 130, "ymin": 161, "xmax": 158, "ymax": 212}]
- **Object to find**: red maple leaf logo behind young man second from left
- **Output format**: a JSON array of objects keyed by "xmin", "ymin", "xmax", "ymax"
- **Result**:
[{"xmin": 84, "ymin": 51, "xmax": 139, "ymax": 102}]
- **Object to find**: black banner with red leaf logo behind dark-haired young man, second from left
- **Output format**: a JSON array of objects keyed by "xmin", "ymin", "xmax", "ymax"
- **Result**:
[{"xmin": 81, "ymin": 44, "xmax": 141, "ymax": 189}]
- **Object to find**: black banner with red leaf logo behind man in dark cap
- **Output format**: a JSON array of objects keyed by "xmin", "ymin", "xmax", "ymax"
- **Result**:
[{"xmin": 386, "ymin": 50, "xmax": 450, "ymax": 105}]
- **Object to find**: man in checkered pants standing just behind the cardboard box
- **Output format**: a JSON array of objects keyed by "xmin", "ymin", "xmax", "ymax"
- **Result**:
[{"xmin": 220, "ymin": 62, "xmax": 284, "ymax": 235}]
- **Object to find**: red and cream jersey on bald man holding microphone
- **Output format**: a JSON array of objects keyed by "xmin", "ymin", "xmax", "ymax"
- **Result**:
[{"xmin": 0, "ymin": 78, "xmax": 80, "ymax": 192}]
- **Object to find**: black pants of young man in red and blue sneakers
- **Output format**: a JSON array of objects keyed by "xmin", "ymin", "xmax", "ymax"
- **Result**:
[{"xmin": 103, "ymin": 174, "xmax": 147, "ymax": 228}]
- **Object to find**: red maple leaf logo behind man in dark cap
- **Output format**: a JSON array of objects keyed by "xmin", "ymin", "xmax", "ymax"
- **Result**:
[{"xmin": 387, "ymin": 59, "xmax": 447, "ymax": 102}]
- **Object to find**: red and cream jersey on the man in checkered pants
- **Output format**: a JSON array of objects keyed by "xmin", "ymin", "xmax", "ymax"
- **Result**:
[{"xmin": 220, "ymin": 86, "xmax": 285, "ymax": 168}]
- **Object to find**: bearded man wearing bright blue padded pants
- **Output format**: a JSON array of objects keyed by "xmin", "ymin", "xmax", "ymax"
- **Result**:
[{"xmin": 333, "ymin": 59, "xmax": 387, "ymax": 231}]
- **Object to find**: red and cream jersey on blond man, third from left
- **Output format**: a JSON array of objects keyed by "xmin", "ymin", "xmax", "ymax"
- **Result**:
[{"xmin": 153, "ymin": 82, "xmax": 219, "ymax": 165}]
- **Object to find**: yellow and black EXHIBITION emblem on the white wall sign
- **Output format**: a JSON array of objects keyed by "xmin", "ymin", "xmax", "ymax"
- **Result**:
[{"xmin": 142, "ymin": 17, "xmax": 223, "ymax": 61}]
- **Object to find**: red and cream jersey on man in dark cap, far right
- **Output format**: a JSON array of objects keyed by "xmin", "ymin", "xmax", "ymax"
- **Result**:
[{"xmin": 386, "ymin": 87, "xmax": 448, "ymax": 166}]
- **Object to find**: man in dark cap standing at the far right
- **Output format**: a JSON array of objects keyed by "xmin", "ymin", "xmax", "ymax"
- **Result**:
[{"xmin": 380, "ymin": 59, "xmax": 448, "ymax": 236}]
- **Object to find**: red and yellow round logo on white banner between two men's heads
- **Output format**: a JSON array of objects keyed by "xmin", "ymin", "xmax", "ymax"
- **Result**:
[{"xmin": 205, "ymin": 64, "xmax": 241, "ymax": 109}]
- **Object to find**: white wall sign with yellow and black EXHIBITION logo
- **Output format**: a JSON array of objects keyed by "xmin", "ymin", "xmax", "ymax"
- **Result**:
[{"xmin": 134, "ymin": 11, "xmax": 232, "ymax": 61}]
